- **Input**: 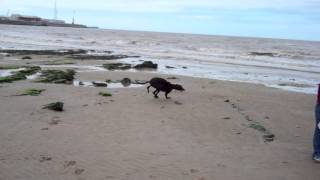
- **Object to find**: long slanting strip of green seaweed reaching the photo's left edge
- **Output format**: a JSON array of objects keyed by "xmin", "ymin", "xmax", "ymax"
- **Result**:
[{"xmin": 0, "ymin": 66, "xmax": 41, "ymax": 83}]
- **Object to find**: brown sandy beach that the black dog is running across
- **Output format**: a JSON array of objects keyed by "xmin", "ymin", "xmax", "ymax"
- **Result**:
[{"xmin": 0, "ymin": 68, "xmax": 320, "ymax": 180}]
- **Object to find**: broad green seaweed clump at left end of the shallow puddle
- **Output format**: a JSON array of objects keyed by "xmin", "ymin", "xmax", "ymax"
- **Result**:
[{"xmin": 36, "ymin": 69, "xmax": 76, "ymax": 84}]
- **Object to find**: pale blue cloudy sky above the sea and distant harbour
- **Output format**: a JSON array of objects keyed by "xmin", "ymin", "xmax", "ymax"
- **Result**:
[{"xmin": 0, "ymin": 0, "xmax": 320, "ymax": 41}]
